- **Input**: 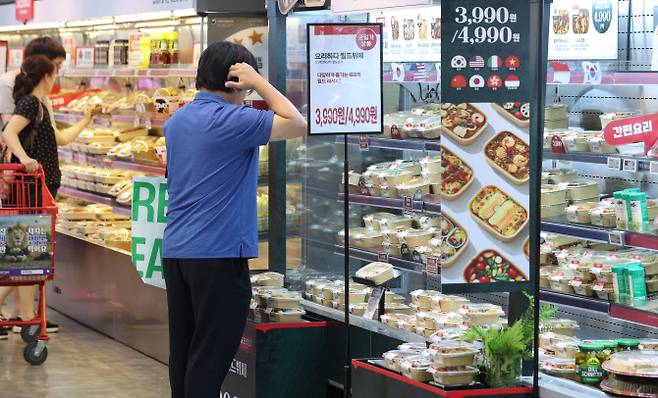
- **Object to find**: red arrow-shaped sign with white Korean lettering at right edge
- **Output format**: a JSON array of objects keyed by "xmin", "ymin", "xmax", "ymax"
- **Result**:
[{"xmin": 603, "ymin": 114, "xmax": 658, "ymax": 153}]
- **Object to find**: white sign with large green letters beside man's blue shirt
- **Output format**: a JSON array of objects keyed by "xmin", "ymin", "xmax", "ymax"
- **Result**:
[{"xmin": 132, "ymin": 177, "xmax": 168, "ymax": 288}]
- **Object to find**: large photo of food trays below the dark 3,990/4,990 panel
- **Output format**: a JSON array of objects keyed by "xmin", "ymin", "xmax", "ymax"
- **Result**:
[{"xmin": 441, "ymin": 102, "xmax": 530, "ymax": 284}]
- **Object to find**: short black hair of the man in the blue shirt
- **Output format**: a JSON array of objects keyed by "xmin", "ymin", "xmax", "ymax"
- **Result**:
[{"xmin": 196, "ymin": 41, "xmax": 258, "ymax": 93}]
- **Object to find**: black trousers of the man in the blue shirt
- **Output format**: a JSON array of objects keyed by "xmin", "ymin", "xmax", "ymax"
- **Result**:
[{"xmin": 163, "ymin": 258, "xmax": 251, "ymax": 398}]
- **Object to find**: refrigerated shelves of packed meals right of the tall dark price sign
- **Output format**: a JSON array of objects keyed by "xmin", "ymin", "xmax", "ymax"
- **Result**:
[{"xmin": 540, "ymin": 1, "xmax": 658, "ymax": 397}]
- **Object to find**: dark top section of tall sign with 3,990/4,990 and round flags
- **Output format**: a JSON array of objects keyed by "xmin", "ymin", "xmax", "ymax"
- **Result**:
[{"xmin": 441, "ymin": 0, "xmax": 531, "ymax": 103}]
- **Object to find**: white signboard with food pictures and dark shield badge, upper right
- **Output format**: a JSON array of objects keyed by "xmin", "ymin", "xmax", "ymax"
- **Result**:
[{"xmin": 548, "ymin": 0, "xmax": 619, "ymax": 60}]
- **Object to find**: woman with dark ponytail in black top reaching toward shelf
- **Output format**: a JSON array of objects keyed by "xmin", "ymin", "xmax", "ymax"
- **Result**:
[{"xmin": 0, "ymin": 55, "xmax": 92, "ymax": 330}]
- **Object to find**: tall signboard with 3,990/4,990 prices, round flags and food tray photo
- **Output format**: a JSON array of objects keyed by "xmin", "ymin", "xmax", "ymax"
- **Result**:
[{"xmin": 440, "ymin": 0, "xmax": 532, "ymax": 293}]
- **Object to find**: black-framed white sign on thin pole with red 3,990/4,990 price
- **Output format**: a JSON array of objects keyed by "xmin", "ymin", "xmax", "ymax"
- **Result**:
[{"xmin": 307, "ymin": 24, "xmax": 384, "ymax": 135}]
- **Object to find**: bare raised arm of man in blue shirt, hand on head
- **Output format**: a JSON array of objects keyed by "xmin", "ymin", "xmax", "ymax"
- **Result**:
[{"xmin": 226, "ymin": 63, "xmax": 308, "ymax": 141}]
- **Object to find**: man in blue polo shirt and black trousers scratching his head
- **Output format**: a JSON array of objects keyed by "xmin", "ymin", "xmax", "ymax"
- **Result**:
[{"xmin": 163, "ymin": 42, "xmax": 307, "ymax": 398}]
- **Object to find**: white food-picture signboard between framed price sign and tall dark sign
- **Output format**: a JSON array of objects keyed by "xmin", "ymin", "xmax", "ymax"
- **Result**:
[{"xmin": 370, "ymin": 7, "xmax": 441, "ymax": 62}]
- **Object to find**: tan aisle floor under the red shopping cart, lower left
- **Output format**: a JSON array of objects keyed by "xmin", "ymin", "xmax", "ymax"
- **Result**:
[{"xmin": 0, "ymin": 311, "xmax": 170, "ymax": 398}]
